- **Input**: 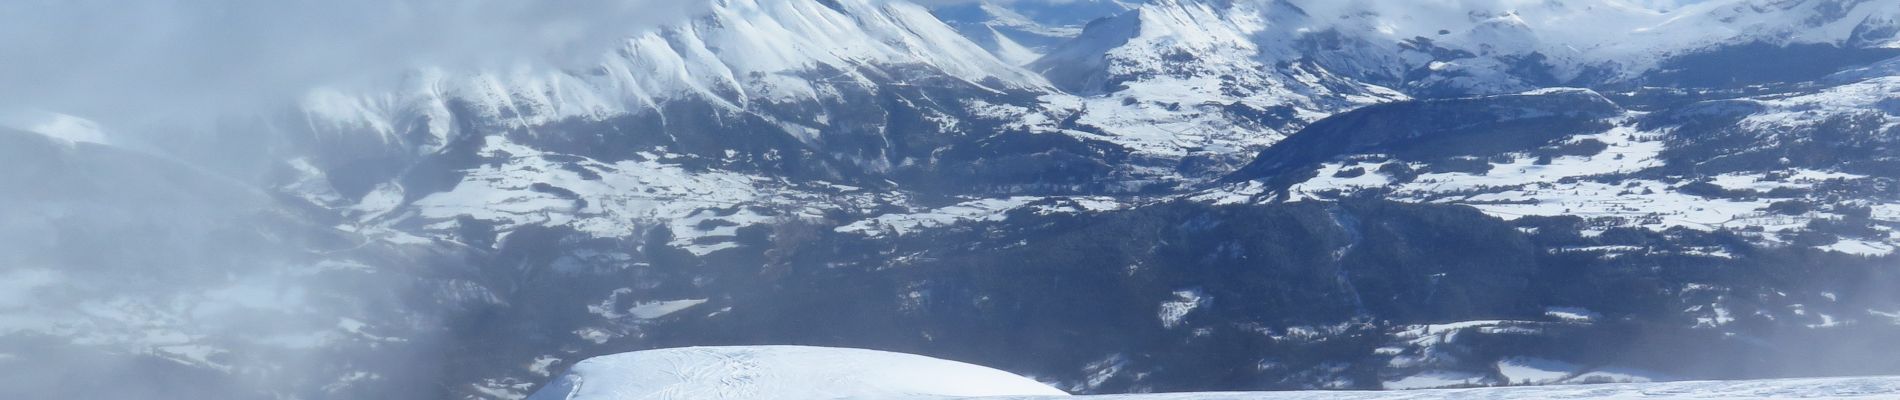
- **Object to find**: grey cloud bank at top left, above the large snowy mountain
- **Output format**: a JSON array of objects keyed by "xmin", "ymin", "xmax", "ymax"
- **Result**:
[{"xmin": 0, "ymin": 0, "xmax": 707, "ymax": 127}]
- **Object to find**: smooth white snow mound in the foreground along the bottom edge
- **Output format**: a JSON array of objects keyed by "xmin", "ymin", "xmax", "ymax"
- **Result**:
[{"xmin": 528, "ymin": 345, "xmax": 1900, "ymax": 400}]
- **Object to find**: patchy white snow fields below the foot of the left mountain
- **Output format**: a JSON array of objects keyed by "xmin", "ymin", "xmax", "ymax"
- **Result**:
[{"xmin": 395, "ymin": 136, "xmax": 901, "ymax": 254}]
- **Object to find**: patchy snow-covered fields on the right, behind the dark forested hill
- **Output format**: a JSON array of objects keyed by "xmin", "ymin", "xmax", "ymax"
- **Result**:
[{"xmin": 1197, "ymin": 78, "xmax": 1900, "ymax": 258}]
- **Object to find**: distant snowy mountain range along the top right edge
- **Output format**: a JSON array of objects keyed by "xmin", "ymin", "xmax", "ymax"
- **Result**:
[{"xmin": 1264, "ymin": 0, "xmax": 1900, "ymax": 95}]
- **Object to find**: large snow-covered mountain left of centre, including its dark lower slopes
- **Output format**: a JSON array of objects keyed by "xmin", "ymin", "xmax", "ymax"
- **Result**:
[{"xmin": 289, "ymin": 0, "xmax": 1047, "ymax": 195}]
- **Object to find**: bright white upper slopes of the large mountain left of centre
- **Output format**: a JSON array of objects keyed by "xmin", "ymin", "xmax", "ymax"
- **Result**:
[{"xmin": 300, "ymin": 0, "xmax": 1047, "ymax": 154}]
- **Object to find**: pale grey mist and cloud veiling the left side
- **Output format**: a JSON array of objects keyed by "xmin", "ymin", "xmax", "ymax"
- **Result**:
[{"xmin": 0, "ymin": 0, "xmax": 707, "ymax": 398}]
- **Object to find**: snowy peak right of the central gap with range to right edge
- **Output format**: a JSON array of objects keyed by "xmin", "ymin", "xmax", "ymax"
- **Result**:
[{"xmin": 1028, "ymin": 0, "xmax": 1900, "ymax": 171}]
